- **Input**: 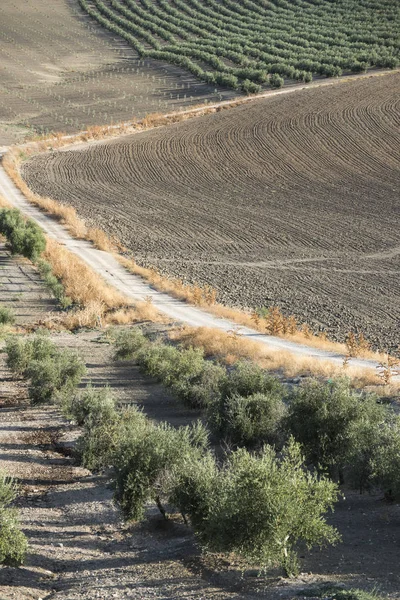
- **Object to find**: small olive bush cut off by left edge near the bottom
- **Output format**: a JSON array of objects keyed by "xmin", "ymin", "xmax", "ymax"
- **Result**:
[{"xmin": 0, "ymin": 474, "xmax": 28, "ymax": 567}]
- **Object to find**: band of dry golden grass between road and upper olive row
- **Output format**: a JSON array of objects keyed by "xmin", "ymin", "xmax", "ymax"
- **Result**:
[{"xmin": 171, "ymin": 327, "xmax": 380, "ymax": 387}]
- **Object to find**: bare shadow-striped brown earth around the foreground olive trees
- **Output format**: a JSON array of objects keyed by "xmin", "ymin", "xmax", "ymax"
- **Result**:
[{"xmin": 0, "ymin": 247, "xmax": 400, "ymax": 600}]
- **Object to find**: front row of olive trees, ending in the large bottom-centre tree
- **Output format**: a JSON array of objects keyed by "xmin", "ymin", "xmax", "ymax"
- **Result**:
[{"xmin": 64, "ymin": 388, "xmax": 339, "ymax": 574}]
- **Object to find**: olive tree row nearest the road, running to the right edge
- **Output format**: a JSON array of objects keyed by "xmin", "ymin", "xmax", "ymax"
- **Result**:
[{"xmin": 111, "ymin": 329, "xmax": 400, "ymax": 498}]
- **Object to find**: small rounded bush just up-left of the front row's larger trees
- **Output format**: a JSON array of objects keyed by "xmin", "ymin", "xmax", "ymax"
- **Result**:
[{"xmin": 64, "ymin": 385, "xmax": 115, "ymax": 427}]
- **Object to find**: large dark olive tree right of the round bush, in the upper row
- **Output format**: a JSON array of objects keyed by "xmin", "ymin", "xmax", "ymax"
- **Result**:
[{"xmin": 286, "ymin": 379, "xmax": 387, "ymax": 481}]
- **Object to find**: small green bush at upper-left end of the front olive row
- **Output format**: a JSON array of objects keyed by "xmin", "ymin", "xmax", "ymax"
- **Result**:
[{"xmin": 5, "ymin": 334, "xmax": 57, "ymax": 375}]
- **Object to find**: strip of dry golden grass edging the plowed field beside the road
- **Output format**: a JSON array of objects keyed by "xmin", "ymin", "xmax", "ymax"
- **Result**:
[{"xmin": 3, "ymin": 119, "xmax": 387, "ymax": 364}]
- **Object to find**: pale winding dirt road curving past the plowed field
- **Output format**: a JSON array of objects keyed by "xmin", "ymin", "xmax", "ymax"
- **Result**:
[{"xmin": 0, "ymin": 161, "xmax": 392, "ymax": 376}]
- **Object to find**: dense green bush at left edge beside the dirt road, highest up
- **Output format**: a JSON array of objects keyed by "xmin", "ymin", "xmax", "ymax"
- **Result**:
[{"xmin": 0, "ymin": 208, "xmax": 46, "ymax": 262}]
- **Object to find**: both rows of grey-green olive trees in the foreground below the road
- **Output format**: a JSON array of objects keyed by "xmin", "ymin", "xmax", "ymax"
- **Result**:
[{"xmin": 6, "ymin": 329, "xmax": 400, "ymax": 575}]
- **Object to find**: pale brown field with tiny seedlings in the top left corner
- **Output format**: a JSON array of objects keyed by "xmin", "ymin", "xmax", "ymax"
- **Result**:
[{"xmin": 0, "ymin": 0, "xmax": 235, "ymax": 146}]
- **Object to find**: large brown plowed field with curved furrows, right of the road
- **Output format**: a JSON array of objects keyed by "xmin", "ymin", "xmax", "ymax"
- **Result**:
[{"xmin": 23, "ymin": 73, "xmax": 400, "ymax": 349}]
